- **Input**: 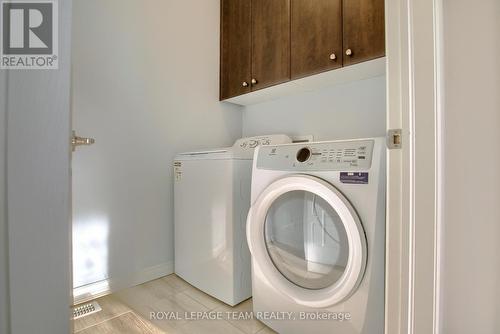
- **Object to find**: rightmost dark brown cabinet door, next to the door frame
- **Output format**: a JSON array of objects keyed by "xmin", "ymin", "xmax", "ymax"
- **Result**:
[{"xmin": 343, "ymin": 0, "xmax": 385, "ymax": 65}]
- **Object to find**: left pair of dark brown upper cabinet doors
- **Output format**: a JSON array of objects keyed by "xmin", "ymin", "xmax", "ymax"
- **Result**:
[{"xmin": 220, "ymin": 0, "xmax": 290, "ymax": 100}]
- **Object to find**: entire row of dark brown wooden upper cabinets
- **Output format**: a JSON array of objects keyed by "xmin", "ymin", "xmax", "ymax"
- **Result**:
[{"xmin": 220, "ymin": 0, "xmax": 385, "ymax": 100}]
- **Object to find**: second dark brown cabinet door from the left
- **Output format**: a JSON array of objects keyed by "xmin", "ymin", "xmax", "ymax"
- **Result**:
[{"xmin": 252, "ymin": 0, "xmax": 290, "ymax": 90}]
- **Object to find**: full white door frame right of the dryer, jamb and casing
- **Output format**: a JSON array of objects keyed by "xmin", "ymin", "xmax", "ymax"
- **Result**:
[{"xmin": 385, "ymin": 0, "xmax": 443, "ymax": 334}]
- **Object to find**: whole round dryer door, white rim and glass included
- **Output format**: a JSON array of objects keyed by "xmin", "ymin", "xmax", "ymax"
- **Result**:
[{"xmin": 247, "ymin": 175, "xmax": 367, "ymax": 308}]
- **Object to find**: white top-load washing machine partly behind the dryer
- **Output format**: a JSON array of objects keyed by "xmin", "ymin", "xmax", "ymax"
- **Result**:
[{"xmin": 174, "ymin": 135, "xmax": 292, "ymax": 305}]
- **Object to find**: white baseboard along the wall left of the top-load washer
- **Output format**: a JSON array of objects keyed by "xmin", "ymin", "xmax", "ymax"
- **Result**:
[{"xmin": 73, "ymin": 261, "xmax": 174, "ymax": 305}]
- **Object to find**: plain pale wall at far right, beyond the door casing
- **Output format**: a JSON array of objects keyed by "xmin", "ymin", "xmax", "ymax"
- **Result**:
[{"xmin": 440, "ymin": 0, "xmax": 500, "ymax": 334}]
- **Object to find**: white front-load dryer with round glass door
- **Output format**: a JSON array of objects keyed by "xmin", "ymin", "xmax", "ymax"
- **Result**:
[{"xmin": 247, "ymin": 138, "xmax": 386, "ymax": 334}]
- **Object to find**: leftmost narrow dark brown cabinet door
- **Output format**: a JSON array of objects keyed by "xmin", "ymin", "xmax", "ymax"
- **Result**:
[{"xmin": 220, "ymin": 0, "xmax": 252, "ymax": 100}]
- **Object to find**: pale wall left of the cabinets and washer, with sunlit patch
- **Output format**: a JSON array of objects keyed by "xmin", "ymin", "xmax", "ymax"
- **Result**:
[{"xmin": 73, "ymin": 0, "xmax": 242, "ymax": 287}]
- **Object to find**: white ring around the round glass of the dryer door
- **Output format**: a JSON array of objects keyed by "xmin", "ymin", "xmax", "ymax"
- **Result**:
[{"xmin": 247, "ymin": 175, "xmax": 367, "ymax": 308}]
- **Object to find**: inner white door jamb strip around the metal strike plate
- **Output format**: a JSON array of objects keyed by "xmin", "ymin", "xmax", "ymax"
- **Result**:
[{"xmin": 385, "ymin": 0, "xmax": 410, "ymax": 334}]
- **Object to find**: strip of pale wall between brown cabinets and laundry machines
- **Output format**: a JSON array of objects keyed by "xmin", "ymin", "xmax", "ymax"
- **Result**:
[{"xmin": 243, "ymin": 77, "xmax": 386, "ymax": 140}]
